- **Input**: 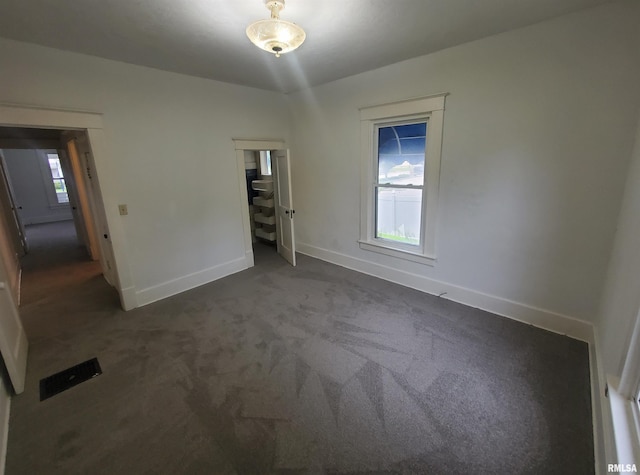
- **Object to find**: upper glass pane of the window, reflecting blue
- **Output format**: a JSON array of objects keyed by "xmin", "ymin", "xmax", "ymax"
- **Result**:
[{"xmin": 378, "ymin": 122, "xmax": 427, "ymax": 186}]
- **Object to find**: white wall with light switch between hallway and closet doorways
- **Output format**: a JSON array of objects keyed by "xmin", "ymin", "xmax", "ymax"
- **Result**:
[{"xmin": 0, "ymin": 40, "xmax": 288, "ymax": 303}]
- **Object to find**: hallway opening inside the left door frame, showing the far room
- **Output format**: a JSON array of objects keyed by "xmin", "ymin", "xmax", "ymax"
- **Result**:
[{"xmin": 0, "ymin": 134, "xmax": 113, "ymax": 298}]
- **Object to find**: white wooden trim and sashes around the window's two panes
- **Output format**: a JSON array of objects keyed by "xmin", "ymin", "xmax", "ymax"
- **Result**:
[{"xmin": 359, "ymin": 93, "xmax": 447, "ymax": 265}]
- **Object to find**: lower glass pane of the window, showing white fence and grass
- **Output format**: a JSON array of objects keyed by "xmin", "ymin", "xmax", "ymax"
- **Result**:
[{"xmin": 376, "ymin": 187, "xmax": 422, "ymax": 246}]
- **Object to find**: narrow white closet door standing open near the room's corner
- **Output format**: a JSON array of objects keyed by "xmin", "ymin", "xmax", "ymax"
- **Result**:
[{"xmin": 271, "ymin": 149, "xmax": 296, "ymax": 266}]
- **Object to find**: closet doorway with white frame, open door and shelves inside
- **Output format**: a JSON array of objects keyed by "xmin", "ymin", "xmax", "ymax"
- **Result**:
[{"xmin": 234, "ymin": 140, "xmax": 296, "ymax": 267}]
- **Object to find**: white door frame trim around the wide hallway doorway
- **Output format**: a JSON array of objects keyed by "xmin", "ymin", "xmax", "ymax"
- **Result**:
[{"xmin": 0, "ymin": 104, "xmax": 137, "ymax": 310}]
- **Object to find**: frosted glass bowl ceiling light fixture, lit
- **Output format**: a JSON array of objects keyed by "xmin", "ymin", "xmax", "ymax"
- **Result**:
[{"xmin": 247, "ymin": 0, "xmax": 307, "ymax": 58}]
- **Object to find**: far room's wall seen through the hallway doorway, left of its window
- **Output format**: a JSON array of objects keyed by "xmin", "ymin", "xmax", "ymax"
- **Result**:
[{"xmin": 2, "ymin": 149, "xmax": 73, "ymax": 225}]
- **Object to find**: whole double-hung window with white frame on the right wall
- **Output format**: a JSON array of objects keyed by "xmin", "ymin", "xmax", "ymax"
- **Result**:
[{"xmin": 360, "ymin": 94, "xmax": 445, "ymax": 264}]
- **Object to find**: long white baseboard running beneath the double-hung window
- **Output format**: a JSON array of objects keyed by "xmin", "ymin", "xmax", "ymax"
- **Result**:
[{"xmin": 296, "ymin": 243, "xmax": 593, "ymax": 343}]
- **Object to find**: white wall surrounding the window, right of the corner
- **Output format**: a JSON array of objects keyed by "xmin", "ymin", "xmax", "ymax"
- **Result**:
[{"xmin": 289, "ymin": 2, "xmax": 640, "ymax": 330}]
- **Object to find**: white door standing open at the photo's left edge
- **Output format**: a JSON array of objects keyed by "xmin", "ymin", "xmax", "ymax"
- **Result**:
[{"xmin": 0, "ymin": 237, "xmax": 29, "ymax": 394}]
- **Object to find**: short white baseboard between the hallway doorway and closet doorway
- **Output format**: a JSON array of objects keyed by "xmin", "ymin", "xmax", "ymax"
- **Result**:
[{"xmin": 136, "ymin": 256, "xmax": 247, "ymax": 306}]
